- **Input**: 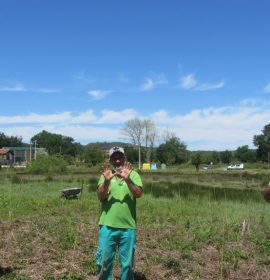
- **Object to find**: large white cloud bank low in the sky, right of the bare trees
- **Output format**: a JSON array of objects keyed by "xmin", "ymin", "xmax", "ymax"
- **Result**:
[{"xmin": 151, "ymin": 104, "xmax": 270, "ymax": 150}]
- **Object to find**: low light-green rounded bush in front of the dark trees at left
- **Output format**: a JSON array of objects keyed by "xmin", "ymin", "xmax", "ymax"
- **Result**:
[{"xmin": 27, "ymin": 155, "xmax": 67, "ymax": 174}]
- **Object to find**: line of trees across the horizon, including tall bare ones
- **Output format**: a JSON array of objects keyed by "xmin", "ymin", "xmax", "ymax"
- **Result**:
[{"xmin": 0, "ymin": 118, "xmax": 270, "ymax": 166}]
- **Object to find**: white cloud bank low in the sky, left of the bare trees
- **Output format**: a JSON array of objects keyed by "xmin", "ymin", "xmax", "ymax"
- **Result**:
[{"xmin": 0, "ymin": 109, "xmax": 137, "ymax": 144}]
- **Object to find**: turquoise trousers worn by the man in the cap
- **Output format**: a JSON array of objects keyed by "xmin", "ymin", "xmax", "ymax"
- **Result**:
[{"xmin": 96, "ymin": 226, "xmax": 136, "ymax": 280}]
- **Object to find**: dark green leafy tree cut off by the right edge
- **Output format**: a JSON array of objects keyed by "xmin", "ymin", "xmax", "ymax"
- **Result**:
[{"xmin": 253, "ymin": 123, "xmax": 270, "ymax": 162}]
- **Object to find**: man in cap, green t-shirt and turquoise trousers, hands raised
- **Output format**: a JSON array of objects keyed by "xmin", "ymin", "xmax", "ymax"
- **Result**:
[{"xmin": 96, "ymin": 147, "xmax": 143, "ymax": 280}]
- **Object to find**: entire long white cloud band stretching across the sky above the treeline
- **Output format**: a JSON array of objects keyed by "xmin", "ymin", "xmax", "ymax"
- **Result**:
[{"xmin": 0, "ymin": 103, "xmax": 270, "ymax": 150}]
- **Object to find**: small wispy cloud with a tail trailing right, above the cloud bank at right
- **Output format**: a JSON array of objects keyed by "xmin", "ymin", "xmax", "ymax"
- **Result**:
[{"xmin": 180, "ymin": 74, "xmax": 225, "ymax": 91}]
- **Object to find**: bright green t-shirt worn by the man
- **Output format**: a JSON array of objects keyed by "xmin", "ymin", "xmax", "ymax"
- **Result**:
[{"xmin": 98, "ymin": 170, "xmax": 142, "ymax": 229}]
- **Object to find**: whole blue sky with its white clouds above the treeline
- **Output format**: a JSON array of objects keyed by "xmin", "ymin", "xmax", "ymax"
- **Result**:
[{"xmin": 0, "ymin": 0, "xmax": 270, "ymax": 150}]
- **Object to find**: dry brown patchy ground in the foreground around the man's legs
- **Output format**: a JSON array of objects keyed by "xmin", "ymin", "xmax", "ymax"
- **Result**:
[{"xmin": 0, "ymin": 220, "xmax": 270, "ymax": 280}]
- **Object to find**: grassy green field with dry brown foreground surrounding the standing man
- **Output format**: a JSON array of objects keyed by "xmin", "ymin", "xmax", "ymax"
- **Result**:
[{"xmin": 0, "ymin": 173, "xmax": 270, "ymax": 280}]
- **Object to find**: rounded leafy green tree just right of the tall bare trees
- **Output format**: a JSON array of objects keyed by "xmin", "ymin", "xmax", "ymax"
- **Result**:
[{"xmin": 157, "ymin": 136, "xmax": 187, "ymax": 164}]
